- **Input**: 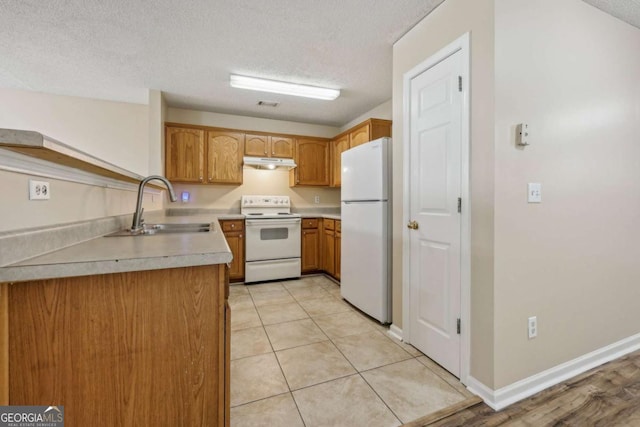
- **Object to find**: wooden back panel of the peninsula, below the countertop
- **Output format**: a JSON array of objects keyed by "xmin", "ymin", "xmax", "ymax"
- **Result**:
[{"xmin": 0, "ymin": 265, "xmax": 230, "ymax": 426}]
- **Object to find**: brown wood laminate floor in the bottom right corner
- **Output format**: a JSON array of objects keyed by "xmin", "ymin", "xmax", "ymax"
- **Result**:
[{"xmin": 411, "ymin": 351, "xmax": 640, "ymax": 427}]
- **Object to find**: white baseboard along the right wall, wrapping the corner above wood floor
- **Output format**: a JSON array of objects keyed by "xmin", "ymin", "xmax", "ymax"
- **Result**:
[{"xmin": 466, "ymin": 334, "xmax": 640, "ymax": 411}]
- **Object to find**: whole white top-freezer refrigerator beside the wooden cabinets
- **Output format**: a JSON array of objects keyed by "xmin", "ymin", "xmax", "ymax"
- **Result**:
[{"xmin": 340, "ymin": 138, "xmax": 391, "ymax": 323}]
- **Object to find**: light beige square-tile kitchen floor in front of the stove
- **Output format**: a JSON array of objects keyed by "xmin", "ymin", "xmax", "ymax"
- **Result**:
[{"xmin": 229, "ymin": 276, "xmax": 471, "ymax": 427}]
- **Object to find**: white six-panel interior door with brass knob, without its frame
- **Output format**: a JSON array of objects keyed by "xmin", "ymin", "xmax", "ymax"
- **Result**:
[{"xmin": 409, "ymin": 51, "xmax": 463, "ymax": 377}]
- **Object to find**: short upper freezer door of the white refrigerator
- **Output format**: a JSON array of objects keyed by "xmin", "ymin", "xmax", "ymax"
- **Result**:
[{"xmin": 340, "ymin": 138, "xmax": 391, "ymax": 201}]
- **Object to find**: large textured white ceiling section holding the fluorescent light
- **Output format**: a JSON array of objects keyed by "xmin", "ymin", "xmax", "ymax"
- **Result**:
[{"xmin": 0, "ymin": 0, "xmax": 442, "ymax": 126}]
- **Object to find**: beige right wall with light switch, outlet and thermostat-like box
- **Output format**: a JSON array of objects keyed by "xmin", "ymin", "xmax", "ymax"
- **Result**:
[{"xmin": 496, "ymin": 0, "xmax": 640, "ymax": 388}]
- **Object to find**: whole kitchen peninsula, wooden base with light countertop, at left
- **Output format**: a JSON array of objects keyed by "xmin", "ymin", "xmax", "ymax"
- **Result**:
[{"xmin": 0, "ymin": 216, "xmax": 232, "ymax": 426}]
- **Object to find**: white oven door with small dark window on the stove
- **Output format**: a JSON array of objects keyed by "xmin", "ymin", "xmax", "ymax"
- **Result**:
[{"xmin": 245, "ymin": 218, "xmax": 302, "ymax": 261}]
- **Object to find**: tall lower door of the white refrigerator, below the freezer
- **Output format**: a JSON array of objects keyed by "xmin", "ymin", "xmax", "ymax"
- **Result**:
[{"xmin": 340, "ymin": 202, "xmax": 391, "ymax": 323}]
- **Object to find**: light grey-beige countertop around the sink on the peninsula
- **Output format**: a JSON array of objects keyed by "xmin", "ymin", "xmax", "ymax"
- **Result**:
[{"xmin": 0, "ymin": 212, "xmax": 232, "ymax": 282}]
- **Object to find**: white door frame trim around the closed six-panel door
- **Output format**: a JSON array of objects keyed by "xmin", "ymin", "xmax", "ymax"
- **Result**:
[{"xmin": 402, "ymin": 32, "xmax": 471, "ymax": 384}]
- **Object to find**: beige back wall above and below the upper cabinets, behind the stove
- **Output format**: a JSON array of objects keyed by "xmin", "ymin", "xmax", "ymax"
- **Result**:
[{"xmin": 166, "ymin": 108, "xmax": 340, "ymax": 210}]
